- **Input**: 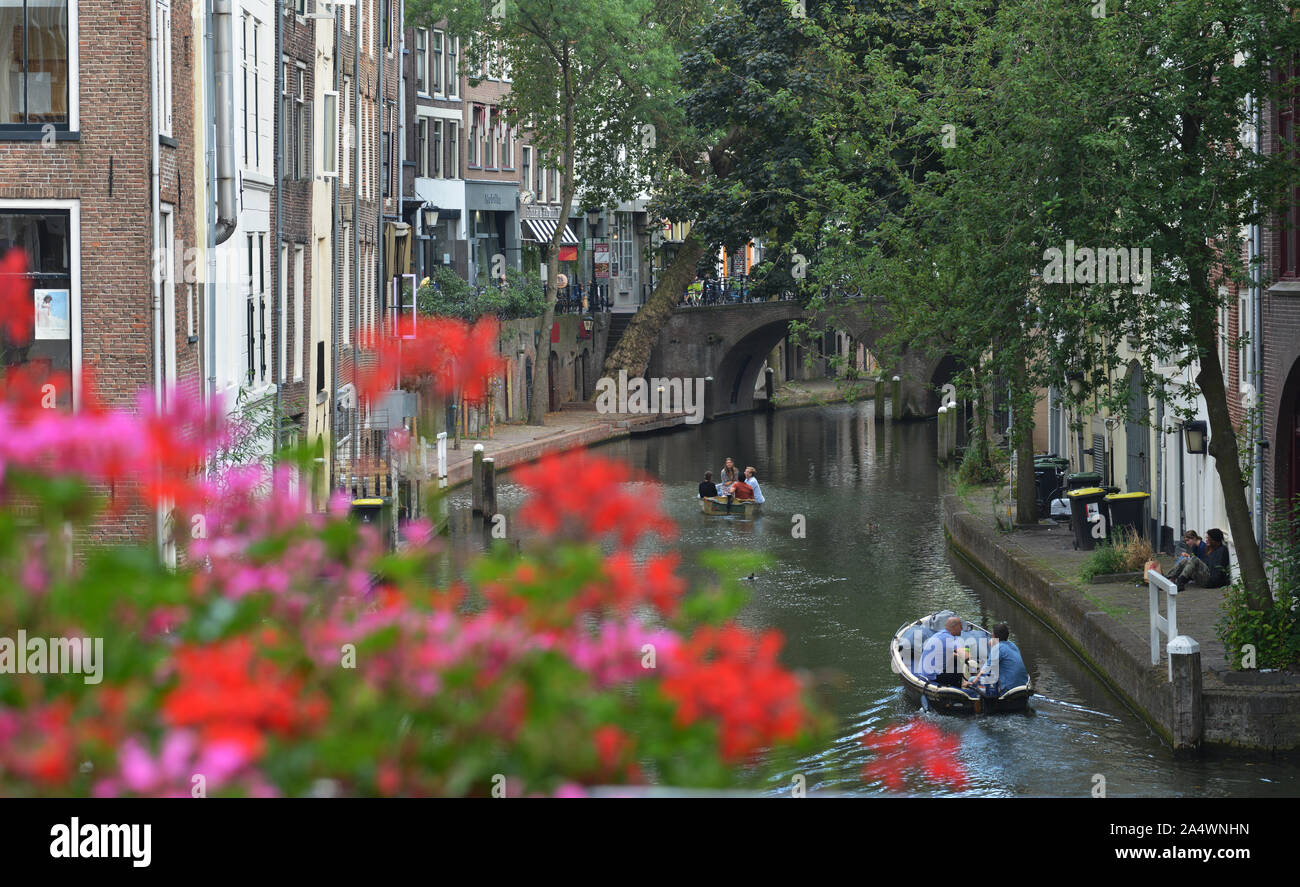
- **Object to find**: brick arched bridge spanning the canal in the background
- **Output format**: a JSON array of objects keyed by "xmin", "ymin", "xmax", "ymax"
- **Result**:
[{"xmin": 646, "ymin": 299, "xmax": 953, "ymax": 417}]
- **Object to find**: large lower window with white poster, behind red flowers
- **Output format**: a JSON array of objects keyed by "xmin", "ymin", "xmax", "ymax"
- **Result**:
[{"xmin": 0, "ymin": 207, "xmax": 74, "ymax": 408}]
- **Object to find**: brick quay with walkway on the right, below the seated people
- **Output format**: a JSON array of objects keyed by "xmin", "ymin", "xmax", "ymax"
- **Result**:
[{"xmin": 944, "ymin": 489, "xmax": 1300, "ymax": 754}]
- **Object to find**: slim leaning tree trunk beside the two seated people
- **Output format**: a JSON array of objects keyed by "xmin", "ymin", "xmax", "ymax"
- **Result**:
[{"xmin": 1192, "ymin": 310, "xmax": 1273, "ymax": 610}]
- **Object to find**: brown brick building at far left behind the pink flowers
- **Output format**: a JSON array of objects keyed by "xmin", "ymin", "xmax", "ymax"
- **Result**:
[{"xmin": 0, "ymin": 0, "xmax": 200, "ymax": 541}]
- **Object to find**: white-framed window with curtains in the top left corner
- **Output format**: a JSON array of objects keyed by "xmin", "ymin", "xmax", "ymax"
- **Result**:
[{"xmin": 0, "ymin": 0, "xmax": 72, "ymax": 129}]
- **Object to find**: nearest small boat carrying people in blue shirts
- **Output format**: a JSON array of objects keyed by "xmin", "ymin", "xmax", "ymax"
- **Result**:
[{"xmin": 889, "ymin": 610, "xmax": 1034, "ymax": 714}]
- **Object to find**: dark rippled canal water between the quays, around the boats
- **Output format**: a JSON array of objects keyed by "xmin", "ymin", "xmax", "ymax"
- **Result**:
[{"xmin": 451, "ymin": 403, "xmax": 1300, "ymax": 797}]
